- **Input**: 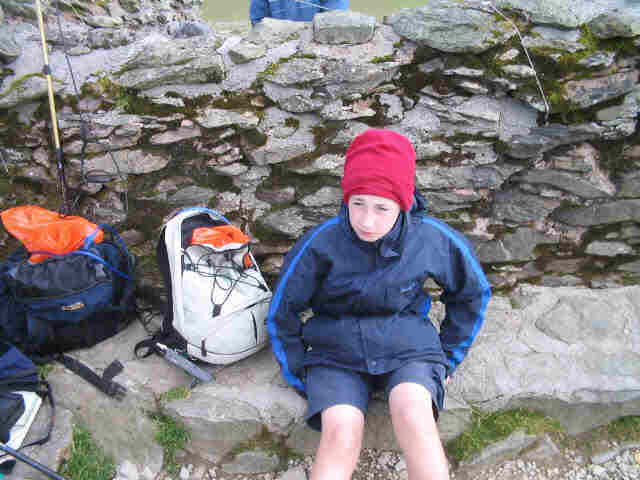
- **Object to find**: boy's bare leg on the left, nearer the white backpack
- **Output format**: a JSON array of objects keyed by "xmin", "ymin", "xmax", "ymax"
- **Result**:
[{"xmin": 310, "ymin": 405, "xmax": 364, "ymax": 480}]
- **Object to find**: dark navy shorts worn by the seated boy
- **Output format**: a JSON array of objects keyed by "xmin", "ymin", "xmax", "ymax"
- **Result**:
[{"xmin": 305, "ymin": 362, "xmax": 445, "ymax": 431}]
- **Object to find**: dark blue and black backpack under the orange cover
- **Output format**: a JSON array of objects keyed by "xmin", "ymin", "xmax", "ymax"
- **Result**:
[{"xmin": 0, "ymin": 225, "xmax": 136, "ymax": 398}]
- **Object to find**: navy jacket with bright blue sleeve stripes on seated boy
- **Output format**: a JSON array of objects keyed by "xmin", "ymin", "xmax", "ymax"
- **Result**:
[{"xmin": 267, "ymin": 194, "xmax": 491, "ymax": 392}]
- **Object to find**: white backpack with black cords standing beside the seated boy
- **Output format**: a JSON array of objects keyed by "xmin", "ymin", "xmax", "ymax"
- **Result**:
[{"xmin": 136, "ymin": 207, "xmax": 271, "ymax": 364}]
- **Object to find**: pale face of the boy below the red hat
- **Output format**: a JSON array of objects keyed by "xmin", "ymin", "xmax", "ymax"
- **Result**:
[{"xmin": 347, "ymin": 195, "xmax": 400, "ymax": 242}]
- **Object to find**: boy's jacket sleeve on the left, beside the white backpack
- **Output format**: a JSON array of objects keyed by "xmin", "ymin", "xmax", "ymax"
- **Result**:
[{"xmin": 267, "ymin": 235, "xmax": 318, "ymax": 394}]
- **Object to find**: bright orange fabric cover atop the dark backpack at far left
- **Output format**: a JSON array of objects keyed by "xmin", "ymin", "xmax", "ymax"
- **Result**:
[{"xmin": 0, "ymin": 205, "xmax": 104, "ymax": 263}]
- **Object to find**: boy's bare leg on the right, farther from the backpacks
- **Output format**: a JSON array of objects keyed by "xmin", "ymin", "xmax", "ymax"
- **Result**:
[{"xmin": 389, "ymin": 383, "xmax": 449, "ymax": 480}]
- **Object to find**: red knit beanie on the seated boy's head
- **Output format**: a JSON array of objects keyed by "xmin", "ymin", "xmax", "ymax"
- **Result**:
[{"xmin": 342, "ymin": 129, "xmax": 416, "ymax": 211}]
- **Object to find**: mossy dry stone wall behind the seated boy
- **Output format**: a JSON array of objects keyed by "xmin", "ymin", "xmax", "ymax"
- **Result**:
[{"xmin": 0, "ymin": 0, "xmax": 640, "ymax": 289}]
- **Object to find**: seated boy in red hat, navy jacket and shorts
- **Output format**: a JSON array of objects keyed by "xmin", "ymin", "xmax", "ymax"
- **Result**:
[{"xmin": 267, "ymin": 129, "xmax": 491, "ymax": 480}]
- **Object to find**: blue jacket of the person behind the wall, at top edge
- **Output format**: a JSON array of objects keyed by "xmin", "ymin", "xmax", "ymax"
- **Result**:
[{"xmin": 249, "ymin": 0, "xmax": 349, "ymax": 25}]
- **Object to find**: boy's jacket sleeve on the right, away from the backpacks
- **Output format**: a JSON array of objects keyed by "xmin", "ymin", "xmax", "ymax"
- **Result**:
[{"xmin": 436, "ymin": 225, "xmax": 491, "ymax": 376}]
